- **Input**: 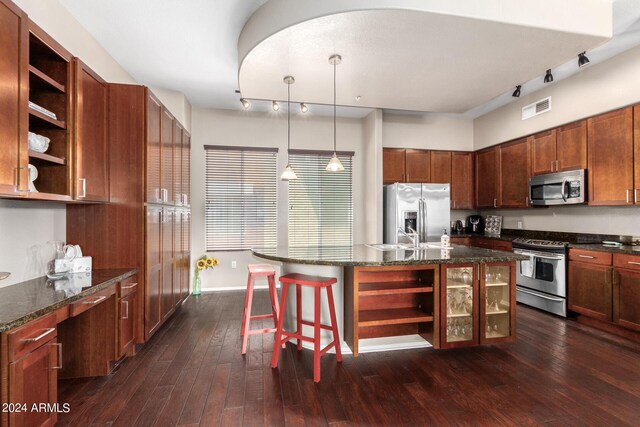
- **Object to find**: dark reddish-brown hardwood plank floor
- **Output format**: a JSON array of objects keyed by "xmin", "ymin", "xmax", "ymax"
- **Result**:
[{"xmin": 59, "ymin": 291, "xmax": 640, "ymax": 426}]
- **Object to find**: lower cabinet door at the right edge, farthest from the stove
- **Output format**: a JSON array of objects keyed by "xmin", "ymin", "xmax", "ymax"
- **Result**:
[{"xmin": 613, "ymin": 269, "xmax": 640, "ymax": 331}]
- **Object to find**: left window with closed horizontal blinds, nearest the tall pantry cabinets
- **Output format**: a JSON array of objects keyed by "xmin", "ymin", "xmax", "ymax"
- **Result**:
[{"xmin": 205, "ymin": 145, "xmax": 278, "ymax": 251}]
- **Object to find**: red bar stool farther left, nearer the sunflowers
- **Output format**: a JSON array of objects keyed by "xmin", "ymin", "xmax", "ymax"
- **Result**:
[{"xmin": 240, "ymin": 264, "xmax": 280, "ymax": 354}]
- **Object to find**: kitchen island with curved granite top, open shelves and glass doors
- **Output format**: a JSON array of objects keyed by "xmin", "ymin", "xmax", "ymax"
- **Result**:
[{"xmin": 253, "ymin": 245, "xmax": 525, "ymax": 356}]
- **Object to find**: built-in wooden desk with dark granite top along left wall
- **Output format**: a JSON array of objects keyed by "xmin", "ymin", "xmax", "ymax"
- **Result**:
[{"xmin": 0, "ymin": 269, "xmax": 138, "ymax": 426}]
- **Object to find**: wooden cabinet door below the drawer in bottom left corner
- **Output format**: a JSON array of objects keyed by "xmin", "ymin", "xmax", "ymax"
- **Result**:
[{"xmin": 9, "ymin": 339, "xmax": 58, "ymax": 427}]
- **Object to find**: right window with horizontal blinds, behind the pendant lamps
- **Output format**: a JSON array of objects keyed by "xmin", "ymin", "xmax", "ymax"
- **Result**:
[{"xmin": 289, "ymin": 150, "xmax": 353, "ymax": 247}]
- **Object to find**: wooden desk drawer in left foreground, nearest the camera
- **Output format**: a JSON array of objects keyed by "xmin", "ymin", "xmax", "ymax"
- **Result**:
[{"xmin": 7, "ymin": 313, "xmax": 57, "ymax": 362}]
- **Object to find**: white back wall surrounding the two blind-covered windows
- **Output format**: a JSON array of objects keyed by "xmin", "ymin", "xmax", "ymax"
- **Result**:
[{"xmin": 191, "ymin": 108, "xmax": 370, "ymax": 289}]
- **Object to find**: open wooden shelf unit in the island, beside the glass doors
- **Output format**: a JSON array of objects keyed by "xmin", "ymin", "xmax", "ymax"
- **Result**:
[{"xmin": 344, "ymin": 265, "xmax": 439, "ymax": 356}]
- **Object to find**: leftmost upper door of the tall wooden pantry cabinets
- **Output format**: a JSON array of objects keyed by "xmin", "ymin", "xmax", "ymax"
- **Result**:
[{"xmin": 146, "ymin": 91, "xmax": 163, "ymax": 203}]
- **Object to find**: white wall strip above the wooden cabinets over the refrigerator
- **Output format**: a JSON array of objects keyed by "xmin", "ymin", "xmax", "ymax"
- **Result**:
[{"xmin": 382, "ymin": 113, "xmax": 473, "ymax": 151}]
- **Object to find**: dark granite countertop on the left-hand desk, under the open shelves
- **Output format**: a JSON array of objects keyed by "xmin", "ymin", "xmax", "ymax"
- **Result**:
[{"xmin": 0, "ymin": 268, "xmax": 138, "ymax": 332}]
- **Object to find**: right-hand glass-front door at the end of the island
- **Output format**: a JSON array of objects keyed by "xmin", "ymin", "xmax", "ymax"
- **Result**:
[{"xmin": 479, "ymin": 263, "xmax": 516, "ymax": 344}]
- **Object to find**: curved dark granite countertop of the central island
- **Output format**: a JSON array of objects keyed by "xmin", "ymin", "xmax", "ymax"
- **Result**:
[{"xmin": 252, "ymin": 245, "xmax": 527, "ymax": 266}]
